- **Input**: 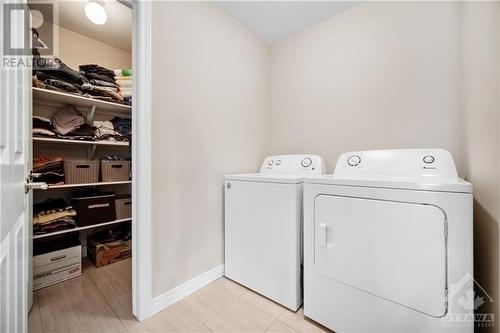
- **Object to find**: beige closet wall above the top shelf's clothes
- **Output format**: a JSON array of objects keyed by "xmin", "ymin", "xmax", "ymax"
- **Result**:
[{"xmin": 57, "ymin": 27, "xmax": 132, "ymax": 70}]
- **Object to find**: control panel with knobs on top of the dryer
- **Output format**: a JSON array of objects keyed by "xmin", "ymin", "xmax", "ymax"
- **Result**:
[{"xmin": 334, "ymin": 149, "xmax": 457, "ymax": 177}]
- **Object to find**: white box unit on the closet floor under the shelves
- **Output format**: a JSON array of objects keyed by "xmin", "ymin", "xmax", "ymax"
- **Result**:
[{"xmin": 33, "ymin": 245, "xmax": 82, "ymax": 290}]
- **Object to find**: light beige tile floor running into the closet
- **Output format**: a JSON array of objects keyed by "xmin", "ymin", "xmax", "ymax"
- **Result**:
[{"xmin": 29, "ymin": 260, "xmax": 329, "ymax": 333}]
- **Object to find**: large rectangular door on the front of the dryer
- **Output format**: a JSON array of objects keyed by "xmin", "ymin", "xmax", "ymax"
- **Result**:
[{"xmin": 314, "ymin": 195, "xmax": 447, "ymax": 317}]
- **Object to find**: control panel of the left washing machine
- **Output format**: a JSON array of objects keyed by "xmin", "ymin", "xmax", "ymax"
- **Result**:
[{"xmin": 260, "ymin": 155, "xmax": 325, "ymax": 175}]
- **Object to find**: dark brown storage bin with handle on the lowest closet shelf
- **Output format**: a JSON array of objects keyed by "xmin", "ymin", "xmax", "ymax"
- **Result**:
[{"xmin": 70, "ymin": 193, "xmax": 116, "ymax": 227}]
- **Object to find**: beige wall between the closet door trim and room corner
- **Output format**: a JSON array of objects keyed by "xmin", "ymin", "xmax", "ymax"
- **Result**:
[{"xmin": 150, "ymin": 2, "xmax": 269, "ymax": 296}]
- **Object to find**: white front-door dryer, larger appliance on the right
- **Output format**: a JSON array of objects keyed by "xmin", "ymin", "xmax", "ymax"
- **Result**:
[{"xmin": 304, "ymin": 149, "xmax": 474, "ymax": 333}]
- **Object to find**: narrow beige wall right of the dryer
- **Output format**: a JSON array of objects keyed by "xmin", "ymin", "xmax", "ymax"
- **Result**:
[{"xmin": 460, "ymin": 2, "xmax": 500, "ymax": 332}]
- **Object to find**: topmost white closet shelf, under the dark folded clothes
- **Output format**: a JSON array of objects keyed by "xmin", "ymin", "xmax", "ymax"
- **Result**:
[{"xmin": 32, "ymin": 87, "xmax": 132, "ymax": 117}]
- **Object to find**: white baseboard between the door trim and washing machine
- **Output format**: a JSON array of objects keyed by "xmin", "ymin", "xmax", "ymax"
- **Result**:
[{"xmin": 151, "ymin": 265, "xmax": 224, "ymax": 315}]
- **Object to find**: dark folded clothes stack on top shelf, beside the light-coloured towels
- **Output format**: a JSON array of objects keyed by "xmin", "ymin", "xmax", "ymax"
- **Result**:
[{"xmin": 80, "ymin": 64, "xmax": 123, "ymax": 103}]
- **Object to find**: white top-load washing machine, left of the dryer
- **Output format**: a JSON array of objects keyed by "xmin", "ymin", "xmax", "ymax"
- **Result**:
[{"xmin": 224, "ymin": 155, "xmax": 324, "ymax": 310}]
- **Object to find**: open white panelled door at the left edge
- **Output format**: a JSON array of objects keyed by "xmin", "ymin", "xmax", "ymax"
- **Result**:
[{"xmin": 0, "ymin": 1, "xmax": 31, "ymax": 333}]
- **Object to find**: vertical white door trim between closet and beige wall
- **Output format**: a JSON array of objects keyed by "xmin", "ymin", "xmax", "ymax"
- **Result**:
[{"xmin": 131, "ymin": 0, "xmax": 153, "ymax": 321}]
